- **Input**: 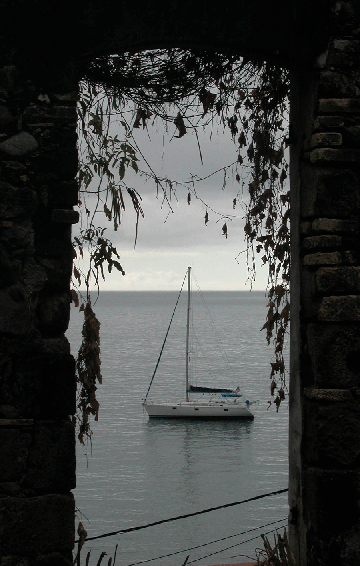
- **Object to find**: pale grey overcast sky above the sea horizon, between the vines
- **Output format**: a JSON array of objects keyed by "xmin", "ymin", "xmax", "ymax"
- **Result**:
[{"xmin": 75, "ymin": 110, "xmax": 267, "ymax": 291}]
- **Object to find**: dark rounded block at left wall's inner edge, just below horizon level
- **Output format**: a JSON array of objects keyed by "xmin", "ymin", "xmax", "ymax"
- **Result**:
[{"xmin": 37, "ymin": 291, "xmax": 71, "ymax": 336}]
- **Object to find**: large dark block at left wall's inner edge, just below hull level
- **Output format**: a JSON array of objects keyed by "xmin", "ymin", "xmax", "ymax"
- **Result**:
[{"xmin": 22, "ymin": 421, "xmax": 76, "ymax": 493}]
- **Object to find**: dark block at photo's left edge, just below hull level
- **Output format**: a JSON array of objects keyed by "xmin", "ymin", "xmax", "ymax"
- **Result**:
[{"xmin": 0, "ymin": 425, "xmax": 31, "ymax": 483}]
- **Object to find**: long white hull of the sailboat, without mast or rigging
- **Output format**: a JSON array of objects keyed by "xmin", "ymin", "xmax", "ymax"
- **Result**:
[{"xmin": 144, "ymin": 401, "xmax": 254, "ymax": 419}]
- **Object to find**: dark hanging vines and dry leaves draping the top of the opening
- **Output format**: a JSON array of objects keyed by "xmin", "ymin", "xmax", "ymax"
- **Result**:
[{"xmin": 73, "ymin": 49, "xmax": 290, "ymax": 441}]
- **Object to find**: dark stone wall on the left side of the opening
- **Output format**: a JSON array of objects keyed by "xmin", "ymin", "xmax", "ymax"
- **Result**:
[{"xmin": 0, "ymin": 57, "xmax": 78, "ymax": 566}]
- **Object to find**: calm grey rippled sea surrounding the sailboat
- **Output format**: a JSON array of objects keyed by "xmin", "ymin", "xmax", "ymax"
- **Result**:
[{"xmin": 67, "ymin": 290, "xmax": 288, "ymax": 566}]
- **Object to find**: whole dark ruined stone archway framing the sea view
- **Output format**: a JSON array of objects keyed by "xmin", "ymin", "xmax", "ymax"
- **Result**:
[{"xmin": 0, "ymin": 0, "xmax": 360, "ymax": 565}]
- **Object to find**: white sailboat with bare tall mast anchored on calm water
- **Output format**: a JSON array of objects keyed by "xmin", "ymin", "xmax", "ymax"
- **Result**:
[{"xmin": 143, "ymin": 267, "xmax": 254, "ymax": 420}]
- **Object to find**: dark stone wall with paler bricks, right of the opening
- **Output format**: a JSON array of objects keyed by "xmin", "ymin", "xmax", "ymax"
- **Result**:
[{"xmin": 290, "ymin": 2, "xmax": 360, "ymax": 566}]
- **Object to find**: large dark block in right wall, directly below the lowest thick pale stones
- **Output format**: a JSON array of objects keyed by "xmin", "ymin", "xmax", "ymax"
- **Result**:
[{"xmin": 307, "ymin": 323, "xmax": 360, "ymax": 389}]
